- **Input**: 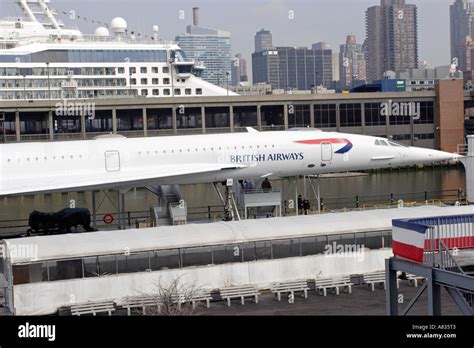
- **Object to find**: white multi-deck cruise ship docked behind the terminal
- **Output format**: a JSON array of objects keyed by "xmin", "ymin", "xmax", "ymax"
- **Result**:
[{"xmin": 0, "ymin": 0, "xmax": 235, "ymax": 100}]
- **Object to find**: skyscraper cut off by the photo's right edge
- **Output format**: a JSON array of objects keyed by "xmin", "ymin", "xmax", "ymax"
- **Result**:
[{"xmin": 449, "ymin": 0, "xmax": 474, "ymax": 71}]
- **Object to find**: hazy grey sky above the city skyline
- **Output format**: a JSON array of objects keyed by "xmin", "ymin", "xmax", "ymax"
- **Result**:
[{"xmin": 0, "ymin": 0, "xmax": 454, "ymax": 73}]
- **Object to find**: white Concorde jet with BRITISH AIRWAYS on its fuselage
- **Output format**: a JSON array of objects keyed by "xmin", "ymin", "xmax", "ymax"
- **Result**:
[{"xmin": 0, "ymin": 128, "xmax": 460, "ymax": 196}]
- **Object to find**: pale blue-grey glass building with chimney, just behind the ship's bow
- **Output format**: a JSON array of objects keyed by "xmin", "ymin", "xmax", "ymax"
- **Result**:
[{"xmin": 176, "ymin": 8, "xmax": 231, "ymax": 85}]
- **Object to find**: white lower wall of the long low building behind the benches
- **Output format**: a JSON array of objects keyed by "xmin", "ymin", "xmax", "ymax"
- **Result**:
[{"xmin": 14, "ymin": 249, "xmax": 392, "ymax": 315}]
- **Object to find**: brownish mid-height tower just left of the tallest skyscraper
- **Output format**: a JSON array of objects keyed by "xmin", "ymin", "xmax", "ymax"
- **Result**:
[{"xmin": 339, "ymin": 34, "xmax": 367, "ymax": 87}]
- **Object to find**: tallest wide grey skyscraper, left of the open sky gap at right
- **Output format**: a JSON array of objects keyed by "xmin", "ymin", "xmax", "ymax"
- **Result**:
[{"xmin": 366, "ymin": 0, "xmax": 418, "ymax": 80}]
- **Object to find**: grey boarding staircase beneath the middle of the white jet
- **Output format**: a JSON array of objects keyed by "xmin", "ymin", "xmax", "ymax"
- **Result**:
[{"xmin": 147, "ymin": 185, "xmax": 187, "ymax": 226}]
